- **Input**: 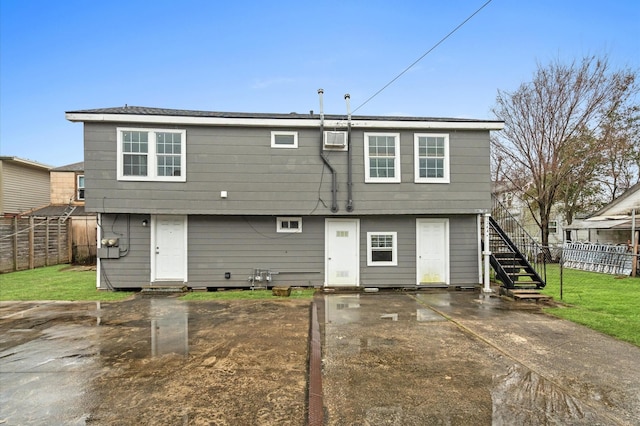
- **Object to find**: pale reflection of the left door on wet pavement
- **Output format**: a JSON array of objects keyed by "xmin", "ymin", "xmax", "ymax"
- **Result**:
[{"xmin": 150, "ymin": 299, "xmax": 189, "ymax": 357}]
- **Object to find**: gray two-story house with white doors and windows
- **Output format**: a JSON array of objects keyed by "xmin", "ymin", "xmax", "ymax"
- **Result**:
[{"xmin": 66, "ymin": 106, "xmax": 503, "ymax": 288}]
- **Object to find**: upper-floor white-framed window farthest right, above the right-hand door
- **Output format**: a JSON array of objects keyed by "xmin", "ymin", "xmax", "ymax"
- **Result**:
[{"xmin": 414, "ymin": 133, "xmax": 449, "ymax": 183}]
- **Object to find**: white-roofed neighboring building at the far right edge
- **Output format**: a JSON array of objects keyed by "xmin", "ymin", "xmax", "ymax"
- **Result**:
[{"xmin": 569, "ymin": 183, "xmax": 640, "ymax": 244}]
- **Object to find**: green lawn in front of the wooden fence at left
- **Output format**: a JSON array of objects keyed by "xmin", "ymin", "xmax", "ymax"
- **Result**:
[{"xmin": 0, "ymin": 265, "xmax": 131, "ymax": 301}]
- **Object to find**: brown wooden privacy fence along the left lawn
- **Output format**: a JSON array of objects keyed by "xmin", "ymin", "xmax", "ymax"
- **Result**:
[{"xmin": 0, "ymin": 217, "xmax": 73, "ymax": 273}]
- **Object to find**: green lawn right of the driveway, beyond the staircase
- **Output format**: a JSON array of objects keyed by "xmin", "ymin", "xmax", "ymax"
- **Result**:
[{"xmin": 542, "ymin": 265, "xmax": 640, "ymax": 346}]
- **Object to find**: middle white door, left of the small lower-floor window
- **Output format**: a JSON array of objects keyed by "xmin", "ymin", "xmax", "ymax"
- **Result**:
[{"xmin": 325, "ymin": 219, "xmax": 360, "ymax": 287}]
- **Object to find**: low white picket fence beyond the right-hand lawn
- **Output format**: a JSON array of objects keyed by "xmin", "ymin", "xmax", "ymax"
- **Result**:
[{"xmin": 562, "ymin": 242, "xmax": 633, "ymax": 275}]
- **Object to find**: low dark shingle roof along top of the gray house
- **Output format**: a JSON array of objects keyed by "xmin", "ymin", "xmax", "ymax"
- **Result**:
[{"xmin": 66, "ymin": 105, "xmax": 502, "ymax": 123}]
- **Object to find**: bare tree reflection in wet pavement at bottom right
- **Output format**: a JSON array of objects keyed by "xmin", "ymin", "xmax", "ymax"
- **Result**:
[{"xmin": 491, "ymin": 365, "xmax": 602, "ymax": 426}]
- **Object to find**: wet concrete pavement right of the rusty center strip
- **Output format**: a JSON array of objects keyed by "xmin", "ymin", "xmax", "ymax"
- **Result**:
[{"xmin": 323, "ymin": 292, "xmax": 640, "ymax": 426}]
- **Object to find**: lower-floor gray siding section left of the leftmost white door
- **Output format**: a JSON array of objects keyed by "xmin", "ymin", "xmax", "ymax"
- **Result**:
[{"xmin": 99, "ymin": 214, "xmax": 151, "ymax": 289}]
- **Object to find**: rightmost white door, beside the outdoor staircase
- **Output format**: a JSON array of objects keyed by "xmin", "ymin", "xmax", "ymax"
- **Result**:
[{"xmin": 416, "ymin": 219, "xmax": 449, "ymax": 285}]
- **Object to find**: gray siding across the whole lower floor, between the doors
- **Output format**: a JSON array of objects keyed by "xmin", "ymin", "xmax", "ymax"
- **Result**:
[{"xmin": 101, "ymin": 214, "xmax": 478, "ymax": 288}]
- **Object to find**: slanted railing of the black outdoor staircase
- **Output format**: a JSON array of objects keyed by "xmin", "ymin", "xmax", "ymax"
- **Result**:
[{"xmin": 489, "ymin": 195, "xmax": 551, "ymax": 282}]
